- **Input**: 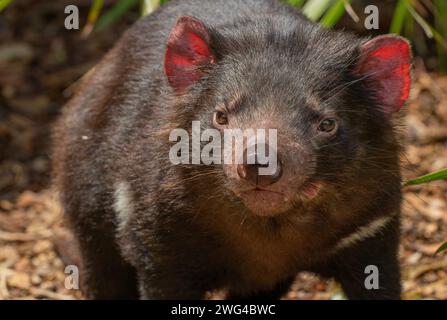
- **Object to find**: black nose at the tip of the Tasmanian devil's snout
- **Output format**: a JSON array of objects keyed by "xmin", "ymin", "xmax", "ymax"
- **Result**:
[{"xmin": 237, "ymin": 146, "xmax": 282, "ymax": 187}]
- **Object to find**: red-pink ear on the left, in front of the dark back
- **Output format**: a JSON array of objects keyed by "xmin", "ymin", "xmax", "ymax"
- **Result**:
[{"xmin": 165, "ymin": 16, "xmax": 214, "ymax": 93}]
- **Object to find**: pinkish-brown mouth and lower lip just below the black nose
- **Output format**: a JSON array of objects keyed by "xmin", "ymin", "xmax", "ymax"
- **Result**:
[{"xmin": 238, "ymin": 182, "xmax": 322, "ymax": 217}]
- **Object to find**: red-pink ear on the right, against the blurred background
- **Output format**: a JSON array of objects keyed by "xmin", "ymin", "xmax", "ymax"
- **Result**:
[{"xmin": 356, "ymin": 35, "xmax": 411, "ymax": 115}]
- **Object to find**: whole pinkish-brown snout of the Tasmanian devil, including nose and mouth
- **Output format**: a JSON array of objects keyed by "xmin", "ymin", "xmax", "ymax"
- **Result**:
[{"xmin": 223, "ymin": 114, "xmax": 320, "ymax": 217}]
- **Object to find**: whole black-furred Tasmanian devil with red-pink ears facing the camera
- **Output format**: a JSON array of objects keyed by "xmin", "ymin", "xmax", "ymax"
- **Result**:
[{"xmin": 50, "ymin": 0, "xmax": 411, "ymax": 299}]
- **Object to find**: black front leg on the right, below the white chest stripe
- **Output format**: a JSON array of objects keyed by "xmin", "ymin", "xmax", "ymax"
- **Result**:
[{"xmin": 319, "ymin": 217, "xmax": 401, "ymax": 300}]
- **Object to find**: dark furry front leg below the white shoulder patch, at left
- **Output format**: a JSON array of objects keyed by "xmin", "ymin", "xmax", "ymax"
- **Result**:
[{"xmin": 121, "ymin": 211, "xmax": 219, "ymax": 300}]
